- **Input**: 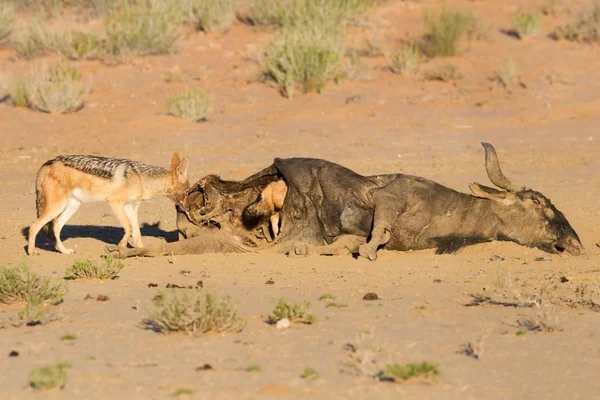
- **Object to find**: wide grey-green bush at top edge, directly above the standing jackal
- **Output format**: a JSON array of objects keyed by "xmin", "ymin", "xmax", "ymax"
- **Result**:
[{"xmin": 105, "ymin": 0, "xmax": 183, "ymax": 57}]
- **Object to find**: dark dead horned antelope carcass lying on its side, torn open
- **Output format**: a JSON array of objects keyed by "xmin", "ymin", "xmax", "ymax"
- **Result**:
[{"xmin": 104, "ymin": 143, "xmax": 582, "ymax": 260}]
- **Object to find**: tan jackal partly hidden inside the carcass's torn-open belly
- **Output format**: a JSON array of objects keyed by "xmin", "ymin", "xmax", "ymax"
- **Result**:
[{"xmin": 242, "ymin": 180, "xmax": 287, "ymax": 239}]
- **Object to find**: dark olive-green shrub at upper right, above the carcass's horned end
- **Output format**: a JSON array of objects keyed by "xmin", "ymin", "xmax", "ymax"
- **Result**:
[{"xmin": 423, "ymin": 10, "xmax": 476, "ymax": 57}]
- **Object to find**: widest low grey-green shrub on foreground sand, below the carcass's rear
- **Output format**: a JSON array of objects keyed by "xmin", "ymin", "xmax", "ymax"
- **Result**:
[{"xmin": 145, "ymin": 290, "xmax": 246, "ymax": 335}]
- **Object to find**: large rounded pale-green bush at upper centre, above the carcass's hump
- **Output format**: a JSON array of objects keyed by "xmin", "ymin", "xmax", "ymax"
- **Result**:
[{"xmin": 263, "ymin": 25, "xmax": 344, "ymax": 97}]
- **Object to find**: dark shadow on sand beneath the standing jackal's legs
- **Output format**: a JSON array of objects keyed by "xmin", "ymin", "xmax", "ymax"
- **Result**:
[{"xmin": 21, "ymin": 222, "xmax": 179, "ymax": 251}]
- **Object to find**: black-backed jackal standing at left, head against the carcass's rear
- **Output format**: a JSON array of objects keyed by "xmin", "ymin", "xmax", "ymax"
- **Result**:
[{"xmin": 27, "ymin": 153, "xmax": 189, "ymax": 255}]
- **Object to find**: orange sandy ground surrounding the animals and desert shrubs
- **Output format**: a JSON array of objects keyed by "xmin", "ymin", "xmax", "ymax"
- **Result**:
[{"xmin": 0, "ymin": 1, "xmax": 600, "ymax": 399}]
